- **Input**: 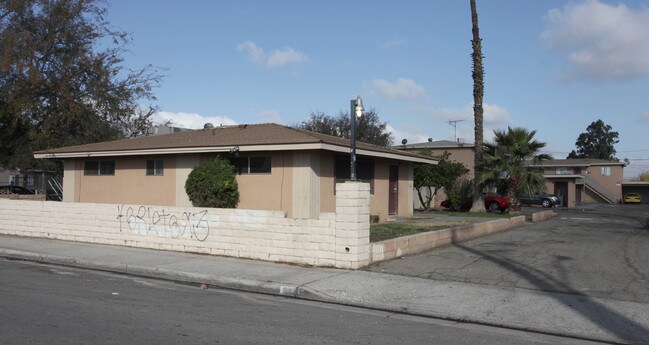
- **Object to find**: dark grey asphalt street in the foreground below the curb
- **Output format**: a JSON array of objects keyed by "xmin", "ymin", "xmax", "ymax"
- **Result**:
[{"xmin": 0, "ymin": 260, "xmax": 589, "ymax": 344}]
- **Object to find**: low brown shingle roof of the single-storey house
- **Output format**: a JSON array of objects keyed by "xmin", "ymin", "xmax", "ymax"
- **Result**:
[{"xmin": 35, "ymin": 123, "xmax": 430, "ymax": 157}]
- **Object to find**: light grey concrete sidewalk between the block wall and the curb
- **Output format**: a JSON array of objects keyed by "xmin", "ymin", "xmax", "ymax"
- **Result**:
[{"xmin": 0, "ymin": 236, "xmax": 649, "ymax": 344}]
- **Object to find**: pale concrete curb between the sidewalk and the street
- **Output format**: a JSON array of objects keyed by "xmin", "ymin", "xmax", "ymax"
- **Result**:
[{"xmin": 0, "ymin": 248, "xmax": 624, "ymax": 344}]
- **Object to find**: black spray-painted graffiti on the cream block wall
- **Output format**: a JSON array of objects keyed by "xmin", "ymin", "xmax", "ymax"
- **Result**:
[{"xmin": 117, "ymin": 205, "xmax": 210, "ymax": 242}]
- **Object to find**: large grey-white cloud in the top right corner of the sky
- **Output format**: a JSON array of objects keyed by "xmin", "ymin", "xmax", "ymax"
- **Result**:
[{"xmin": 541, "ymin": 0, "xmax": 649, "ymax": 81}]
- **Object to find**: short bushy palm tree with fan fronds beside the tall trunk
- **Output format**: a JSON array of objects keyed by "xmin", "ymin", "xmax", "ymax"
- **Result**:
[{"xmin": 476, "ymin": 127, "xmax": 552, "ymax": 213}]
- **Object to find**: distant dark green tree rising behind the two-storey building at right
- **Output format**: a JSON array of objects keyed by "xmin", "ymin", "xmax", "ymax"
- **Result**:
[{"xmin": 568, "ymin": 120, "xmax": 620, "ymax": 161}]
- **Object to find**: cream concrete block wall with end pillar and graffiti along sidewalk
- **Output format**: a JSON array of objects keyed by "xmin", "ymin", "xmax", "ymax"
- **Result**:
[{"xmin": 0, "ymin": 183, "xmax": 369, "ymax": 268}]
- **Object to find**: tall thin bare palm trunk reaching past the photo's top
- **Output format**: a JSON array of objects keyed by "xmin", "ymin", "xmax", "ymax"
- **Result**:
[{"xmin": 471, "ymin": 0, "xmax": 484, "ymax": 212}]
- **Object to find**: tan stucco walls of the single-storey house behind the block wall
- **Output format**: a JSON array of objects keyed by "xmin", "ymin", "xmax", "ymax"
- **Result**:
[{"xmin": 64, "ymin": 151, "xmax": 413, "ymax": 221}]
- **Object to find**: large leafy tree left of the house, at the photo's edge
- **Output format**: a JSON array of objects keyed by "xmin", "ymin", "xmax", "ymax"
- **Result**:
[{"xmin": 0, "ymin": 0, "xmax": 160, "ymax": 170}]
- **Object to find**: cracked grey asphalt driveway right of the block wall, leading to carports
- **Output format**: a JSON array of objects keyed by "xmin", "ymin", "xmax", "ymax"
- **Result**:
[{"xmin": 367, "ymin": 205, "xmax": 649, "ymax": 303}]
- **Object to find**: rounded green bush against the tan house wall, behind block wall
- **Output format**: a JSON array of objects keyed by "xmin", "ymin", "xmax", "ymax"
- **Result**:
[{"xmin": 185, "ymin": 157, "xmax": 239, "ymax": 208}]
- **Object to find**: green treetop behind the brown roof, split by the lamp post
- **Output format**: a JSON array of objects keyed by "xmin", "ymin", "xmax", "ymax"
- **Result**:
[{"xmin": 295, "ymin": 109, "xmax": 394, "ymax": 147}]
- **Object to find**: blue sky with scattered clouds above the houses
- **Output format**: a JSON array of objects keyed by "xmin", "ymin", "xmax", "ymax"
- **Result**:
[{"xmin": 108, "ymin": 0, "xmax": 649, "ymax": 177}]
